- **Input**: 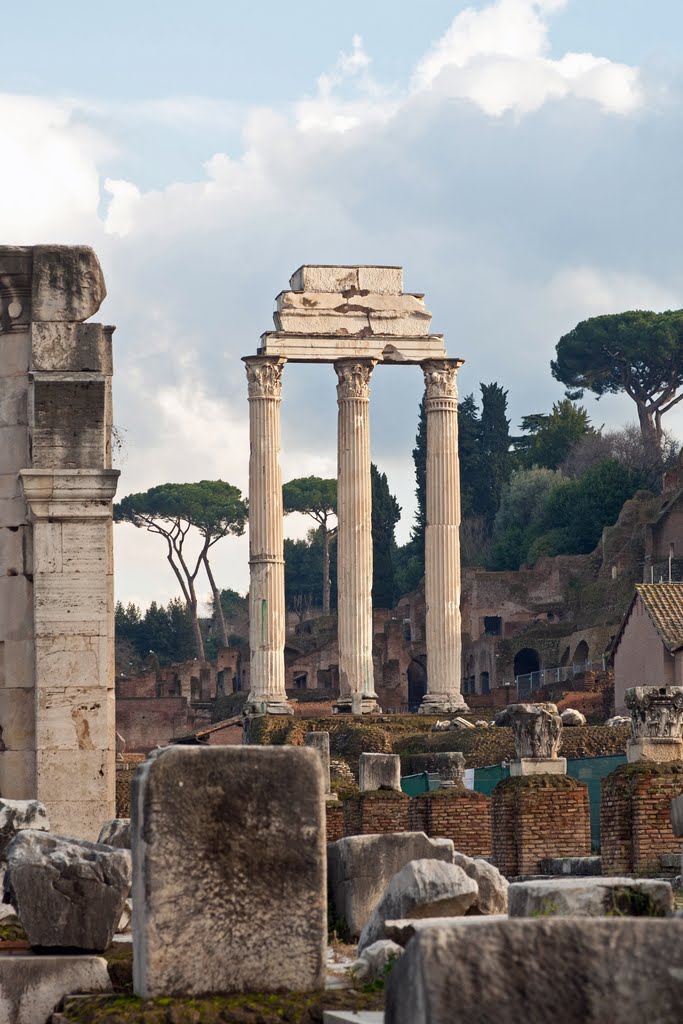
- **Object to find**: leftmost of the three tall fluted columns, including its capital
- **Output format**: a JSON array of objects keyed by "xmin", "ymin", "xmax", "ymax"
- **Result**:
[{"xmin": 244, "ymin": 355, "xmax": 292, "ymax": 715}]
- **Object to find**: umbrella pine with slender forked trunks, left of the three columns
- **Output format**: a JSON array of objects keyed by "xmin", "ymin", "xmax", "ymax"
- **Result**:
[{"xmin": 114, "ymin": 480, "xmax": 247, "ymax": 658}]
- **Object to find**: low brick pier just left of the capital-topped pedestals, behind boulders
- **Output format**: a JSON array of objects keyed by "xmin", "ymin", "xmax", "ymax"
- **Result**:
[{"xmin": 411, "ymin": 788, "xmax": 492, "ymax": 857}]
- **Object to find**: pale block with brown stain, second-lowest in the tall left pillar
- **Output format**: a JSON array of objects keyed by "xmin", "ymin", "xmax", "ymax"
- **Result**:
[{"xmin": 35, "ymin": 688, "xmax": 112, "ymax": 751}]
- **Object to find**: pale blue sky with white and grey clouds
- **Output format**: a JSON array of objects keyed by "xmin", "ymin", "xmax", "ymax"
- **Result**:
[{"xmin": 0, "ymin": 0, "xmax": 683, "ymax": 606}]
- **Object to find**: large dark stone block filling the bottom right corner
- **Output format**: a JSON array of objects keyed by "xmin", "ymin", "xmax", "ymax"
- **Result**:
[{"xmin": 385, "ymin": 918, "xmax": 683, "ymax": 1024}]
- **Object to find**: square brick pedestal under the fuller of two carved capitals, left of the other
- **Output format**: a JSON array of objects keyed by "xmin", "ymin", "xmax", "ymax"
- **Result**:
[{"xmin": 492, "ymin": 775, "xmax": 591, "ymax": 877}]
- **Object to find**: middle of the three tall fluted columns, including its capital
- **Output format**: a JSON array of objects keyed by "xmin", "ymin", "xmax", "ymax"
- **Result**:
[{"xmin": 335, "ymin": 358, "xmax": 380, "ymax": 715}]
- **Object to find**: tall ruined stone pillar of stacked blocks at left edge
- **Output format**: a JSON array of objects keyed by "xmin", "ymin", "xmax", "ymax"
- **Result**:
[{"xmin": 0, "ymin": 246, "xmax": 119, "ymax": 839}]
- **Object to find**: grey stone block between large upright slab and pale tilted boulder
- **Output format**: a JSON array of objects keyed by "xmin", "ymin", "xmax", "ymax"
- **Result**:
[{"xmin": 328, "ymin": 831, "xmax": 454, "ymax": 939}]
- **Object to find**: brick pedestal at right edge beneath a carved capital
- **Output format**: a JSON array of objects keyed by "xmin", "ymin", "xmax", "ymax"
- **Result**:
[{"xmin": 600, "ymin": 761, "xmax": 683, "ymax": 874}]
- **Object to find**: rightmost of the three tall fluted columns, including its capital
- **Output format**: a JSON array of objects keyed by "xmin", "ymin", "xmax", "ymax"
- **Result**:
[{"xmin": 420, "ymin": 359, "xmax": 467, "ymax": 714}]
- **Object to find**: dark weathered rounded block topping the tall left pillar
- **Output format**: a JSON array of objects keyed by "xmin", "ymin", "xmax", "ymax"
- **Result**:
[{"xmin": 31, "ymin": 246, "xmax": 106, "ymax": 321}]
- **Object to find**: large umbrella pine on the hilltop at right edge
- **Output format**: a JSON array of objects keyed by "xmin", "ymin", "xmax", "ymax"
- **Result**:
[{"xmin": 551, "ymin": 309, "xmax": 683, "ymax": 452}]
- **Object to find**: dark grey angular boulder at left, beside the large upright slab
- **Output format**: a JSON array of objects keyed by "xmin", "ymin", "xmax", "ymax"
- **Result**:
[{"xmin": 5, "ymin": 830, "xmax": 131, "ymax": 952}]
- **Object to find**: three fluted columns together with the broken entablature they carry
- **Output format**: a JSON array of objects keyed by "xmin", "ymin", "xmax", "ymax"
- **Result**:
[{"xmin": 245, "ymin": 266, "xmax": 466, "ymax": 714}]
